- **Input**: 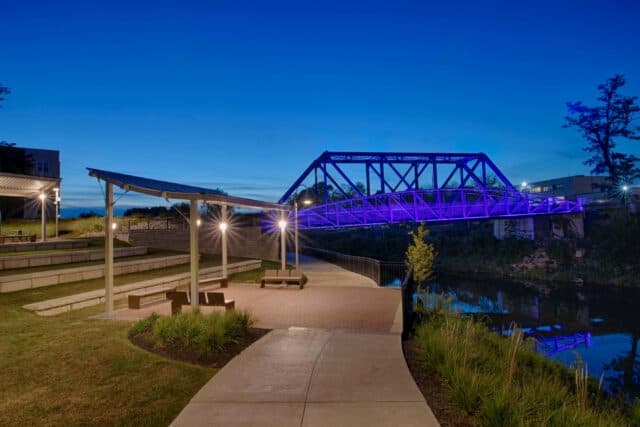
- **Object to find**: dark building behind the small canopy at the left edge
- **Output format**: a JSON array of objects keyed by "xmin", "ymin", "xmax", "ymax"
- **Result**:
[{"xmin": 0, "ymin": 146, "xmax": 60, "ymax": 219}]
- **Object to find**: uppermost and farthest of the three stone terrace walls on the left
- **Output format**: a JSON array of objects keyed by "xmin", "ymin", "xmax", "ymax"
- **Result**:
[{"xmin": 0, "ymin": 246, "xmax": 148, "ymax": 270}]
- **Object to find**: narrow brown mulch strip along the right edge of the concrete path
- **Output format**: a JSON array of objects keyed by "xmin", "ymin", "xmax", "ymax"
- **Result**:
[{"xmin": 402, "ymin": 340, "xmax": 476, "ymax": 427}]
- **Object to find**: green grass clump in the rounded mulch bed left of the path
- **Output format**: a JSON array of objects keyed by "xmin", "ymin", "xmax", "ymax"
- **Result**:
[{"xmin": 129, "ymin": 310, "xmax": 252, "ymax": 356}]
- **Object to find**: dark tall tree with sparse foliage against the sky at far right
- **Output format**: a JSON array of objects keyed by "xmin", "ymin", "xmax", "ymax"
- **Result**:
[{"xmin": 564, "ymin": 74, "xmax": 640, "ymax": 186}]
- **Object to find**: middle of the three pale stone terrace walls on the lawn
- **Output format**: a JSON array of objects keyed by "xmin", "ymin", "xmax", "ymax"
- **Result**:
[{"xmin": 0, "ymin": 255, "xmax": 190, "ymax": 293}]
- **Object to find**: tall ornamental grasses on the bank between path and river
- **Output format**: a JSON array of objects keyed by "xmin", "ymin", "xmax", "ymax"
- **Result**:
[{"xmin": 413, "ymin": 299, "xmax": 640, "ymax": 426}]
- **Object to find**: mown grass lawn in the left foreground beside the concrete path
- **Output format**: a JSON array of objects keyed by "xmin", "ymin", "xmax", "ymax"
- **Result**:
[{"xmin": 0, "ymin": 284, "xmax": 216, "ymax": 426}]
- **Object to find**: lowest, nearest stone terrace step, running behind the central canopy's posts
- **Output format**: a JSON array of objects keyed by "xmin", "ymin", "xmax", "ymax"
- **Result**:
[{"xmin": 23, "ymin": 255, "xmax": 262, "ymax": 316}]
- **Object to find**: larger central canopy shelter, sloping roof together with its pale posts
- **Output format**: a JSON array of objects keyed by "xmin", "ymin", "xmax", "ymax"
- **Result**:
[{"xmin": 87, "ymin": 168, "xmax": 290, "ymax": 316}]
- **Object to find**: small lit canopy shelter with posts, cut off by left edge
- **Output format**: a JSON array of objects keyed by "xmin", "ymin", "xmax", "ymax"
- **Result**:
[{"xmin": 0, "ymin": 172, "xmax": 60, "ymax": 241}]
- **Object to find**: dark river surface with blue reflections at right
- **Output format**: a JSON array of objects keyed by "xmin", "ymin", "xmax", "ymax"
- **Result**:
[{"xmin": 416, "ymin": 276, "xmax": 640, "ymax": 398}]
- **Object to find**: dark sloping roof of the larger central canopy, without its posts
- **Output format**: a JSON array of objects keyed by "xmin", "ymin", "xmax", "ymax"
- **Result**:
[{"xmin": 87, "ymin": 168, "xmax": 290, "ymax": 210}]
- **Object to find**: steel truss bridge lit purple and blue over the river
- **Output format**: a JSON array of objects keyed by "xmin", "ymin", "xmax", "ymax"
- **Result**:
[{"xmin": 279, "ymin": 151, "xmax": 582, "ymax": 229}]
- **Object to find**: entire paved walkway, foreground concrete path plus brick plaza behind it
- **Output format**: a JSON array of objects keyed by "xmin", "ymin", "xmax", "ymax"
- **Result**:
[{"xmin": 172, "ymin": 257, "xmax": 439, "ymax": 427}]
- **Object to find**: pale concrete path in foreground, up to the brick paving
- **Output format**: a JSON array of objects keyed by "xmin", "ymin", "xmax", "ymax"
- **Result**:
[{"xmin": 172, "ymin": 328, "xmax": 439, "ymax": 427}]
